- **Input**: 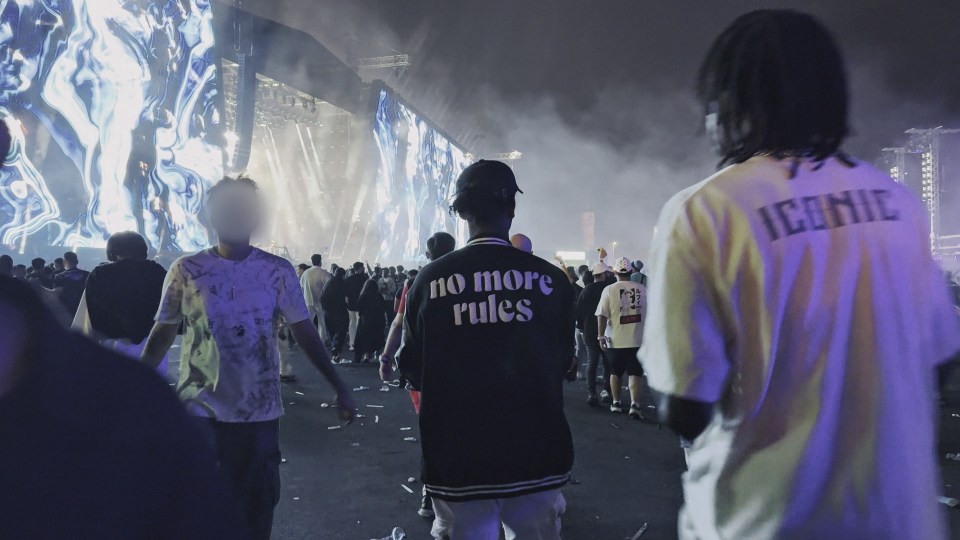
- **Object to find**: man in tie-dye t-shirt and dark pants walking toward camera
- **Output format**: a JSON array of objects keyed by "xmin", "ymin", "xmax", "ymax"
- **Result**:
[{"xmin": 143, "ymin": 177, "xmax": 355, "ymax": 540}]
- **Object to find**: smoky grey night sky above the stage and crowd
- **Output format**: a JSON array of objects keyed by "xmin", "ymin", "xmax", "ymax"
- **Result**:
[{"xmin": 244, "ymin": 0, "xmax": 960, "ymax": 257}]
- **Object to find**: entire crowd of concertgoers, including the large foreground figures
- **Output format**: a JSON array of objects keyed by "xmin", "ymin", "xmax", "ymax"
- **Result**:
[{"xmin": 0, "ymin": 10, "xmax": 960, "ymax": 540}]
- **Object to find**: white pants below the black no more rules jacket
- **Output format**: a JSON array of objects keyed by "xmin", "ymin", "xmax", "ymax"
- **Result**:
[{"xmin": 431, "ymin": 489, "xmax": 567, "ymax": 540}]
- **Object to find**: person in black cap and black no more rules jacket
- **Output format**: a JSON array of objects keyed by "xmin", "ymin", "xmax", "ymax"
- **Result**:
[{"xmin": 398, "ymin": 160, "xmax": 576, "ymax": 539}]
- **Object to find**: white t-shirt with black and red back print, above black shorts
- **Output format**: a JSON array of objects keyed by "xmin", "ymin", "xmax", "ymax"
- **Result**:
[{"xmin": 594, "ymin": 281, "xmax": 647, "ymax": 349}]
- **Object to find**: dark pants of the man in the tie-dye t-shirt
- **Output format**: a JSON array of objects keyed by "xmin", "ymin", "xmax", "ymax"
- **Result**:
[{"xmin": 200, "ymin": 419, "xmax": 280, "ymax": 540}]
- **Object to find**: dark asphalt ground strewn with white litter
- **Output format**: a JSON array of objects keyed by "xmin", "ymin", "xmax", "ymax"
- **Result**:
[{"xmin": 169, "ymin": 346, "xmax": 960, "ymax": 540}]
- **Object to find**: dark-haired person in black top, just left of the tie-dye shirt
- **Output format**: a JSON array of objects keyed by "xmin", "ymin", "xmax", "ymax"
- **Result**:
[{"xmin": 73, "ymin": 231, "xmax": 167, "ymax": 377}]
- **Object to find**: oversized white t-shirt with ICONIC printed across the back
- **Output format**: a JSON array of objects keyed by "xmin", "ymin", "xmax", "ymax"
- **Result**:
[{"xmin": 640, "ymin": 157, "xmax": 960, "ymax": 540}]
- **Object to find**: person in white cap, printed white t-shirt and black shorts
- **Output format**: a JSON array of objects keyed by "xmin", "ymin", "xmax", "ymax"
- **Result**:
[{"xmin": 596, "ymin": 257, "xmax": 647, "ymax": 420}]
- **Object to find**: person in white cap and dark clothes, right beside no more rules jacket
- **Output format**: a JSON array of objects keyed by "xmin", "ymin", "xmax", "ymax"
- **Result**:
[{"xmin": 577, "ymin": 262, "xmax": 613, "ymax": 407}]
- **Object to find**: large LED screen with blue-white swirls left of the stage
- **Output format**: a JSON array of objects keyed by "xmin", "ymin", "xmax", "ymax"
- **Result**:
[{"xmin": 0, "ymin": 0, "xmax": 222, "ymax": 251}]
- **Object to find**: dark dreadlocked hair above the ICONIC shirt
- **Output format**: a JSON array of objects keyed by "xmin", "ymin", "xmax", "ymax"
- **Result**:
[{"xmin": 697, "ymin": 9, "xmax": 855, "ymax": 174}]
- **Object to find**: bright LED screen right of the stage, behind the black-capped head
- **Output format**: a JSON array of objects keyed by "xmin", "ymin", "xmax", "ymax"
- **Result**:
[{"xmin": 373, "ymin": 90, "xmax": 470, "ymax": 264}]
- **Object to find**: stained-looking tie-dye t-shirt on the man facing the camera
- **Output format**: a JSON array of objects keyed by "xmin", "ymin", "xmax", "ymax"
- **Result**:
[{"xmin": 156, "ymin": 248, "xmax": 309, "ymax": 422}]
